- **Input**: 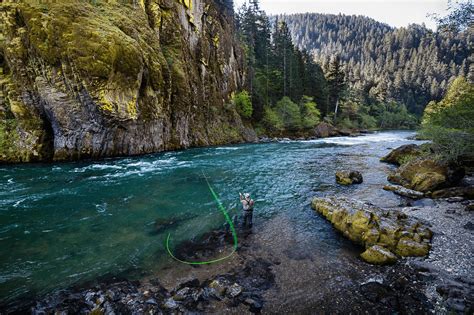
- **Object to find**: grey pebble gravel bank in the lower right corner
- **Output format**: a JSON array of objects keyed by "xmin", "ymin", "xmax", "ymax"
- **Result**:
[{"xmin": 401, "ymin": 199, "xmax": 474, "ymax": 314}]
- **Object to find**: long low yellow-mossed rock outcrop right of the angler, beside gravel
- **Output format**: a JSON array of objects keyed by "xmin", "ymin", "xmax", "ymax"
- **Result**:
[{"xmin": 312, "ymin": 197, "xmax": 432, "ymax": 264}]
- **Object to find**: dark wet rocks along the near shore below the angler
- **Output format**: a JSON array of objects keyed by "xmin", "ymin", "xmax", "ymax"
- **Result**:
[{"xmin": 4, "ymin": 230, "xmax": 275, "ymax": 314}]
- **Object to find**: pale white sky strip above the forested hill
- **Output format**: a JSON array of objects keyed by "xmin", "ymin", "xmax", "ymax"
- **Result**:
[{"xmin": 234, "ymin": 0, "xmax": 448, "ymax": 29}]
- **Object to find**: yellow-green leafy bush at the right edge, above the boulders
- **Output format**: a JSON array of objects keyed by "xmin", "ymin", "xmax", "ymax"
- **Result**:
[{"xmin": 421, "ymin": 77, "xmax": 474, "ymax": 160}]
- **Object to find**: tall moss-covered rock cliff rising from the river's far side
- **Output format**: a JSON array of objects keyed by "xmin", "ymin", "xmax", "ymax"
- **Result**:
[{"xmin": 0, "ymin": 0, "xmax": 254, "ymax": 162}]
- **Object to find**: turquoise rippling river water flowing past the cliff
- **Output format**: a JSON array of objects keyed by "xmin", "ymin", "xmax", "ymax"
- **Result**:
[{"xmin": 0, "ymin": 131, "xmax": 422, "ymax": 305}]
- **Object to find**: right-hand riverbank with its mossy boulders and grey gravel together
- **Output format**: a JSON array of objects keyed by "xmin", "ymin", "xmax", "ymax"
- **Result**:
[{"xmin": 312, "ymin": 144, "xmax": 474, "ymax": 314}]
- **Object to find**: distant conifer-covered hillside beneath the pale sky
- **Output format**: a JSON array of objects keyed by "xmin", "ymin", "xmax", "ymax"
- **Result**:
[{"xmin": 276, "ymin": 13, "xmax": 474, "ymax": 115}]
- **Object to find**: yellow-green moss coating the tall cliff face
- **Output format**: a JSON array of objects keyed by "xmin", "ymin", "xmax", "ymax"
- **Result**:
[{"xmin": 0, "ymin": 0, "xmax": 246, "ymax": 159}]
